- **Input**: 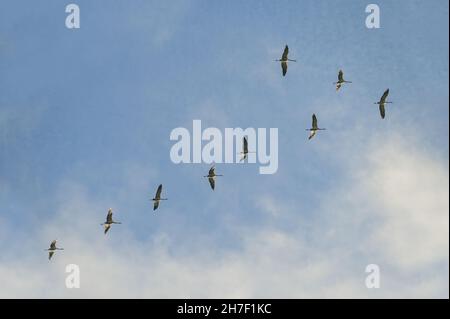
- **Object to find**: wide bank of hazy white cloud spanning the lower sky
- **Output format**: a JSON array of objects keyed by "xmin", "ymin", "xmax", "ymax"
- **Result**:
[{"xmin": 0, "ymin": 131, "xmax": 449, "ymax": 298}]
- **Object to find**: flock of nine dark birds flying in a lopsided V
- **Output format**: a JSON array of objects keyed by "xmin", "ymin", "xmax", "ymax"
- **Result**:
[{"xmin": 46, "ymin": 45, "xmax": 392, "ymax": 260}]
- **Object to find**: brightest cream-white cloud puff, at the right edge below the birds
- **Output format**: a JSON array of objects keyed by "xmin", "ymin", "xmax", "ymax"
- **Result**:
[{"xmin": 364, "ymin": 139, "xmax": 449, "ymax": 271}]
